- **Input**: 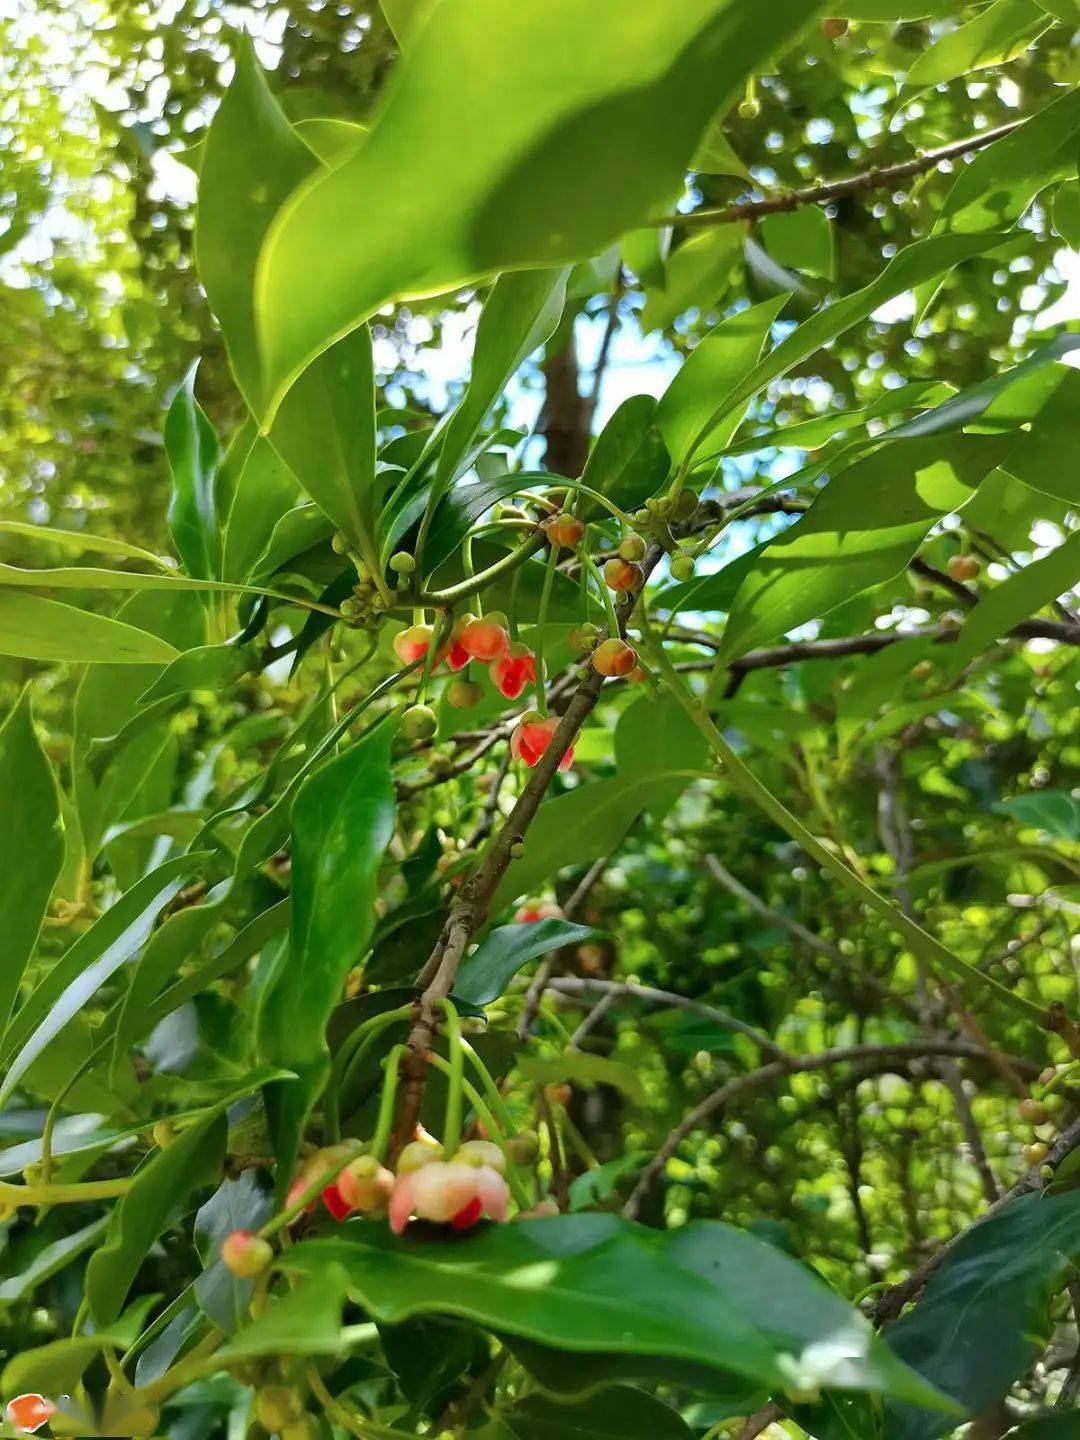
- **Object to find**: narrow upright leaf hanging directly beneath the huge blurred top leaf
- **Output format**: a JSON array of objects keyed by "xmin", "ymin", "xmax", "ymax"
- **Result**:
[{"xmin": 432, "ymin": 269, "xmax": 569, "ymax": 518}]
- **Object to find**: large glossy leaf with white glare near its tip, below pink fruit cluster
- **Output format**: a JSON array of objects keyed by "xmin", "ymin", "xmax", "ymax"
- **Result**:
[{"xmin": 282, "ymin": 1215, "xmax": 943, "ymax": 1405}]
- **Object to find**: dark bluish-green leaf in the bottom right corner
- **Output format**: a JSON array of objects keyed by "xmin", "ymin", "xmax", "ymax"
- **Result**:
[{"xmin": 886, "ymin": 1191, "xmax": 1080, "ymax": 1440}]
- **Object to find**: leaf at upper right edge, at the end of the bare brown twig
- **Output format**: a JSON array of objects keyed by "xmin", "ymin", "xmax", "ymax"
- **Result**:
[{"xmin": 923, "ymin": 89, "xmax": 1080, "ymax": 234}]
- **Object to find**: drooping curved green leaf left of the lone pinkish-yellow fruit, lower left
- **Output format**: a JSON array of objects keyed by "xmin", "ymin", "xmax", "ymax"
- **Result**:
[{"xmin": 86, "ymin": 1109, "xmax": 228, "ymax": 1325}]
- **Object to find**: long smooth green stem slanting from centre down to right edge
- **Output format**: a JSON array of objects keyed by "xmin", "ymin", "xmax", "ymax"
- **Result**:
[{"xmin": 648, "ymin": 636, "xmax": 1045, "ymax": 1025}]
